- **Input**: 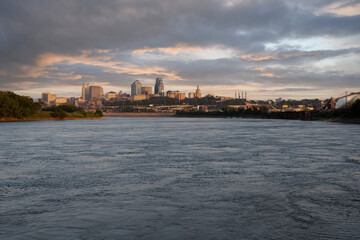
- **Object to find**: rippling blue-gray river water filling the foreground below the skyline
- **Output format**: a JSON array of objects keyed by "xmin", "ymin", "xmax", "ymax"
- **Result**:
[{"xmin": 0, "ymin": 118, "xmax": 360, "ymax": 239}]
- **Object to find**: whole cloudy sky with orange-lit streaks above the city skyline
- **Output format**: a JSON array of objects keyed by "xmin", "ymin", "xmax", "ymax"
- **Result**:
[{"xmin": 0, "ymin": 0, "xmax": 360, "ymax": 99}]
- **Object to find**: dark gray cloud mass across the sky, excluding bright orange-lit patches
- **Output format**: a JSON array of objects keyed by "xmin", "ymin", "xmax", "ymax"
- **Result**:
[{"xmin": 0, "ymin": 0, "xmax": 360, "ymax": 98}]
